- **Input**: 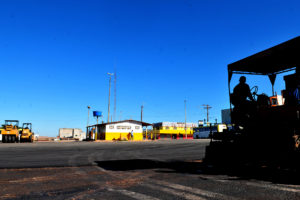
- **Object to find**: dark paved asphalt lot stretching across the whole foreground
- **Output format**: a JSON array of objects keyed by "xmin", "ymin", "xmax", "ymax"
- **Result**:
[{"xmin": 0, "ymin": 140, "xmax": 300, "ymax": 200}]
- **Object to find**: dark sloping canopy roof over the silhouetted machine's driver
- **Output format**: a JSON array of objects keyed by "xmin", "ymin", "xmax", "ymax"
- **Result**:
[{"xmin": 228, "ymin": 36, "xmax": 300, "ymax": 75}]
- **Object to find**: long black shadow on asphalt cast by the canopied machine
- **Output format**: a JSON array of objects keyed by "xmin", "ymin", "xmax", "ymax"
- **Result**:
[{"xmin": 96, "ymin": 159, "xmax": 300, "ymax": 185}]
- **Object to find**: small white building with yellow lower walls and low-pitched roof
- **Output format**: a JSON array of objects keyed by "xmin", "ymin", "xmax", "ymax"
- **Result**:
[{"xmin": 87, "ymin": 120, "xmax": 152, "ymax": 141}]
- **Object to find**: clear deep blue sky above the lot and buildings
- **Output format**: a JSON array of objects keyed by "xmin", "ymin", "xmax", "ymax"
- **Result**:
[{"xmin": 0, "ymin": 0, "xmax": 300, "ymax": 136}]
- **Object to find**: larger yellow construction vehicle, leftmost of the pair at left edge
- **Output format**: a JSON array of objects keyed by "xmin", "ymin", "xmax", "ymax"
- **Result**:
[{"xmin": 1, "ymin": 120, "xmax": 19, "ymax": 143}]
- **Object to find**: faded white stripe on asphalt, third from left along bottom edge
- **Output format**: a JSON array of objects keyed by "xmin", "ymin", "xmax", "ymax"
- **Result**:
[{"xmin": 152, "ymin": 179, "xmax": 239, "ymax": 200}]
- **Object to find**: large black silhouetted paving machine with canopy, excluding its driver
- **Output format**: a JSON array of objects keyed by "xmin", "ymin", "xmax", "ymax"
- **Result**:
[{"xmin": 205, "ymin": 37, "xmax": 300, "ymax": 165}]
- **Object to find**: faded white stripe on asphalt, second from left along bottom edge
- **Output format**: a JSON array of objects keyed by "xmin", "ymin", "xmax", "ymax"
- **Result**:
[{"xmin": 141, "ymin": 183, "xmax": 205, "ymax": 200}]
